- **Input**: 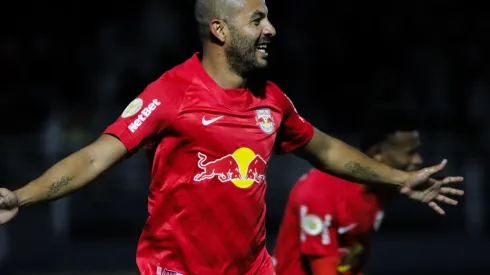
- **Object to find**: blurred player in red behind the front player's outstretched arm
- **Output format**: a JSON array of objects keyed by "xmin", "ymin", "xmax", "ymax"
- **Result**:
[{"xmin": 273, "ymin": 105, "xmax": 432, "ymax": 275}]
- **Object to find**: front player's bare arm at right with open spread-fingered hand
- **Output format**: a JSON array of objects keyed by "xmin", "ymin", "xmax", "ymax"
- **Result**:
[{"xmin": 295, "ymin": 129, "xmax": 464, "ymax": 214}]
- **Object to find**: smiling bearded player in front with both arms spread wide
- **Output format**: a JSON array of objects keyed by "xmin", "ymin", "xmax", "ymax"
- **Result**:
[{"xmin": 0, "ymin": 0, "xmax": 463, "ymax": 275}]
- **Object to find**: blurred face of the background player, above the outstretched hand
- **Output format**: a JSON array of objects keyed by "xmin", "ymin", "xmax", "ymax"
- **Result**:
[{"xmin": 379, "ymin": 131, "xmax": 423, "ymax": 172}]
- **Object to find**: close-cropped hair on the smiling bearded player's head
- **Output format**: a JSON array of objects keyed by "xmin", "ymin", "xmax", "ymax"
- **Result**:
[{"xmin": 194, "ymin": 0, "xmax": 245, "ymax": 42}]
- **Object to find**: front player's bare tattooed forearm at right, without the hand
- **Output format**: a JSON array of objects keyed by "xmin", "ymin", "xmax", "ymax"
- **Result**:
[{"xmin": 295, "ymin": 129, "xmax": 409, "ymax": 187}]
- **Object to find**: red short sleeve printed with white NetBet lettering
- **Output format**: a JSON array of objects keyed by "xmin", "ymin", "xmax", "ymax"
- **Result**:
[{"xmin": 103, "ymin": 78, "xmax": 183, "ymax": 152}]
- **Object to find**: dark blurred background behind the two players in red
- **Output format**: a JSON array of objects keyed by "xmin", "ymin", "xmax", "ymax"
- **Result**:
[{"xmin": 0, "ymin": 0, "xmax": 490, "ymax": 275}]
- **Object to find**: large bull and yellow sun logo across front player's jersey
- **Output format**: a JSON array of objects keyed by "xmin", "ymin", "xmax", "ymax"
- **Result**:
[{"xmin": 194, "ymin": 147, "xmax": 267, "ymax": 188}]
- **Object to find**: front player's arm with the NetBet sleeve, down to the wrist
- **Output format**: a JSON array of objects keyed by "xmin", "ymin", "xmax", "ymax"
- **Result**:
[{"xmin": 15, "ymin": 77, "xmax": 183, "ymax": 208}]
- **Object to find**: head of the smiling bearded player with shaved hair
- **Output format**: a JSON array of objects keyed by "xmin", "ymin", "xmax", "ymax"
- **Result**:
[{"xmin": 194, "ymin": 0, "xmax": 276, "ymax": 76}]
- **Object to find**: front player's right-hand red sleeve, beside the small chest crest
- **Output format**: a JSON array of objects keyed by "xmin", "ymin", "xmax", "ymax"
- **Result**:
[{"xmin": 275, "ymin": 85, "xmax": 313, "ymax": 153}]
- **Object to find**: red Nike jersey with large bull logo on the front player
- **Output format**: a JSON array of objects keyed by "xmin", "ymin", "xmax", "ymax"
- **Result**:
[{"xmin": 104, "ymin": 54, "xmax": 313, "ymax": 275}]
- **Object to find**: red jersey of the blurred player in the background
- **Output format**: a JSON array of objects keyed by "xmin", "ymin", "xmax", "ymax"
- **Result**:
[{"xmin": 273, "ymin": 169, "xmax": 383, "ymax": 275}]
